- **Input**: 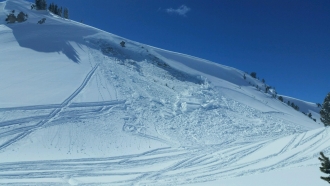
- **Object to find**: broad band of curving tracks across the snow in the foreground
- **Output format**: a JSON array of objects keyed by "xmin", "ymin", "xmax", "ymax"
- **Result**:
[{"xmin": 0, "ymin": 129, "xmax": 330, "ymax": 185}]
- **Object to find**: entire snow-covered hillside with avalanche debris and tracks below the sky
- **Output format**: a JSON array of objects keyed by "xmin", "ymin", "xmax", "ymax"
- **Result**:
[{"xmin": 0, "ymin": 0, "xmax": 330, "ymax": 186}]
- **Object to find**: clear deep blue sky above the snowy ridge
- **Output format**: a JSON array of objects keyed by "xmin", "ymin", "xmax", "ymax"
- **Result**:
[{"xmin": 25, "ymin": 0, "xmax": 330, "ymax": 103}]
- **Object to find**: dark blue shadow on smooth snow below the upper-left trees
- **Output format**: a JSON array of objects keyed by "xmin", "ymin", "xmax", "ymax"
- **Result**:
[{"xmin": 8, "ymin": 24, "xmax": 94, "ymax": 63}]
